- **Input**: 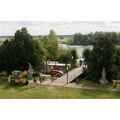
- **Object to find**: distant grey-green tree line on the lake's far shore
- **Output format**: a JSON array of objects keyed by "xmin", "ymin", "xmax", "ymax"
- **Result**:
[{"xmin": 67, "ymin": 32, "xmax": 120, "ymax": 45}]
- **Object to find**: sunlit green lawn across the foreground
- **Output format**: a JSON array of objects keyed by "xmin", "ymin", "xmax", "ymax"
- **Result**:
[{"xmin": 0, "ymin": 80, "xmax": 120, "ymax": 99}]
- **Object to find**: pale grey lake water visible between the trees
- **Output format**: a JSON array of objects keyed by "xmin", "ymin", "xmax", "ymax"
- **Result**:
[{"xmin": 59, "ymin": 44, "xmax": 93, "ymax": 57}]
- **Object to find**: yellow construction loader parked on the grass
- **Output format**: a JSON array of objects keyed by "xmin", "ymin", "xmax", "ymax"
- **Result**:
[{"xmin": 8, "ymin": 70, "xmax": 29, "ymax": 86}]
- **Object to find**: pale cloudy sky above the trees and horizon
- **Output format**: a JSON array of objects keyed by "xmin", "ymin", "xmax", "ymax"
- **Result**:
[{"xmin": 0, "ymin": 21, "xmax": 120, "ymax": 36}]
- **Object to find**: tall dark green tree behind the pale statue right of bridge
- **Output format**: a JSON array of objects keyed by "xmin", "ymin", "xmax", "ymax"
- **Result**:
[{"xmin": 88, "ymin": 37, "xmax": 115, "ymax": 82}]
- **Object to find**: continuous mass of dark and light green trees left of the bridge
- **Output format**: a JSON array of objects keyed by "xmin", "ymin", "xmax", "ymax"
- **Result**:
[{"xmin": 0, "ymin": 28, "xmax": 77, "ymax": 73}]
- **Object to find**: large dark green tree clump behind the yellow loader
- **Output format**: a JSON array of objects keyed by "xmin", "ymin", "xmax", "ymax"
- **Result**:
[{"xmin": 0, "ymin": 28, "xmax": 44, "ymax": 72}]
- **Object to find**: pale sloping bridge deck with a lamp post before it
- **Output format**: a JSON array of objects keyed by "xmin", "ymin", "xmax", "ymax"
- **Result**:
[{"xmin": 50, "ymin": 67, "xmax": 82, "ymax": 86}]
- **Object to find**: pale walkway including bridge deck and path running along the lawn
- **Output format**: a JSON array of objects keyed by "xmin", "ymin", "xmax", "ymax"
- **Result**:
[{"xmin": 29, "ymin": 67, "xmax": 120, "ymax": 92}]
